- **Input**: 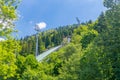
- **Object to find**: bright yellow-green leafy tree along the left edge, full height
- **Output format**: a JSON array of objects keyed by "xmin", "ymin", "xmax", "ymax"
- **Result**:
[{"xmin": 0, "ymin": 0, "xmax": 20, "ymax": 80}]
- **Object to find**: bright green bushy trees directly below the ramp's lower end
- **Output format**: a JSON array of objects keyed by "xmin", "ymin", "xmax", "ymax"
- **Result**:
[{"xmin": 14, "ymin": 55, "xmax": 53, "ymax": 80}]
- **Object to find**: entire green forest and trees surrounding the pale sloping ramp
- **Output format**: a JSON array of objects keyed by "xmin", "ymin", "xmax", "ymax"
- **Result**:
[{"xmin": 0, "ymin": 0, "xmax": 120, "ymax": 80}]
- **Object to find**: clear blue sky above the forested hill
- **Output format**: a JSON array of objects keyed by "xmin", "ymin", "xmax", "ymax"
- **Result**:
[{"xmin": 16, "ymin": 0, "xmax": 105, "ymax": 37}]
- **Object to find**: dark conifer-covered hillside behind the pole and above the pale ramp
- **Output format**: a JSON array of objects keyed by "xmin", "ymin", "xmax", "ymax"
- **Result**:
[{"xmin": 20, "ymin": 24, "xmax": 78, "ymax": 56}]
